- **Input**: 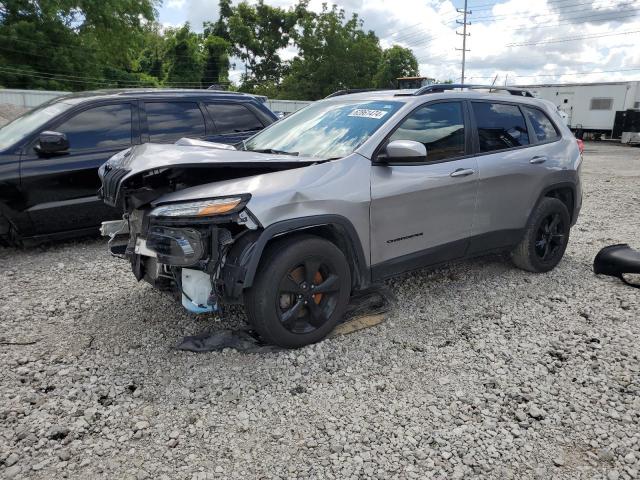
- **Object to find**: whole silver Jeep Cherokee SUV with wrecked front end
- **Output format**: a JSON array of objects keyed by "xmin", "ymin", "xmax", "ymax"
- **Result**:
[{"xmin": 101, "ymin": 85, "xmax": 582, "ymax": 347}]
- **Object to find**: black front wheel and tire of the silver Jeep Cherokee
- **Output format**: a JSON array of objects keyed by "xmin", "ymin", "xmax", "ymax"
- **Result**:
[{"xmin": 245, "ymin": 235, "xmax": 351, "ymax": 348}]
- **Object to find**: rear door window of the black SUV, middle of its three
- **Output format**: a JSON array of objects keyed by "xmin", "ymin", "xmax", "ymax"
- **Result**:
[{"xmin": 145, "ymin": 102, "xmax": 205, "ymax": 143}]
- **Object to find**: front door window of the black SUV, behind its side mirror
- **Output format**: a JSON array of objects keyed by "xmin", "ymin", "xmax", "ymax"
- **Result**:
[{"xmin": 55, "ymin": 103, "xmax": 131, "ymax": 151}]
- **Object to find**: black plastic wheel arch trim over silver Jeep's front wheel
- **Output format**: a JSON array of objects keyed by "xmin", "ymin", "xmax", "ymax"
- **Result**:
[{"xmin": 222, "ymin": 215, "xmax": 371, "ymax": 299}]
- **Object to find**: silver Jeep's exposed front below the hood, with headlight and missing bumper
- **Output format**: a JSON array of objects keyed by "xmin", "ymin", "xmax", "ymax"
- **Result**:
[{"xmin": 110, "ymin": 196, "xmax": 258, "ymax": 313}]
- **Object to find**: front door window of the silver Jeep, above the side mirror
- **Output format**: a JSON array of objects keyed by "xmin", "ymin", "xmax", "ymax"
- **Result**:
[{"xmin": 389, "ymin": 102, "xmax": 465, "ymax": 161}]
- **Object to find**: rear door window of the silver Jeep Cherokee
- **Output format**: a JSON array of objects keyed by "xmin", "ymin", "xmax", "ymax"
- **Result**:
[{"xmin": 472, "ymin": 102, "xmax": 529, "ymax": 152}]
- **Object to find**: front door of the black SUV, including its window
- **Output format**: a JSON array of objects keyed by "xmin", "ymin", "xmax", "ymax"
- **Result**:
[{"xmin": 20, "ymin": 102, "xmax": 140, "ymax": 234}]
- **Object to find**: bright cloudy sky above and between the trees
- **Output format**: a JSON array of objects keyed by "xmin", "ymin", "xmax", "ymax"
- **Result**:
[{"xmin": 159, "ymin": 0, "xmax": 640, "ymax": 85}]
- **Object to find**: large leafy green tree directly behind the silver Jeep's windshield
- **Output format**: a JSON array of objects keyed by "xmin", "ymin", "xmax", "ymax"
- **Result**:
[{"xmin": 280, "ymin": 4, "xmax": 382, "ymax": 100}]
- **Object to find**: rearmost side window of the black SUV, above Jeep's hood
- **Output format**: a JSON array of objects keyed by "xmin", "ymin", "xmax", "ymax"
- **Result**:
[{"xmin": 205, "ymin": 101, "xmax": 265, "ymax": 144}]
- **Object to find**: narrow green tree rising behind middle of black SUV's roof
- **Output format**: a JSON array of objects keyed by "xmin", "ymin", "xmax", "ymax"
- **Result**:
[{"xmin": 165, "ymin": 22, "xmax": 202, "ymax": 88}]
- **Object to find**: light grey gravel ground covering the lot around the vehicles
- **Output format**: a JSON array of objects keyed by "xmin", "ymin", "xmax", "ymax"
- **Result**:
[{"xmin": 0, "ymin": 144, "xmax": 640, "ymax": 480}]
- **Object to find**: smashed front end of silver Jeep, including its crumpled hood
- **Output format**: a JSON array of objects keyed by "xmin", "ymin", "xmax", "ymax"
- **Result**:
[{"xmin": 100, "ymin": 145, "xmax": 320, "ymax": 313}]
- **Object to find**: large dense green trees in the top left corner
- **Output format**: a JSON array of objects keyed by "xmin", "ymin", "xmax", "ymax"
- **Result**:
[{"xmin": 0, "ymin": 0, "xmax": 157, "ymax": 90}]
